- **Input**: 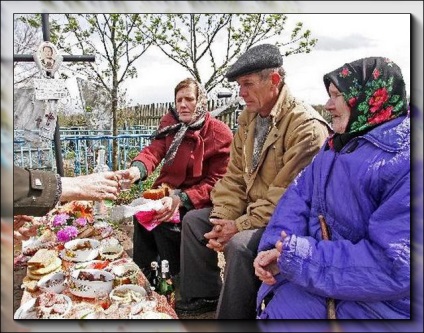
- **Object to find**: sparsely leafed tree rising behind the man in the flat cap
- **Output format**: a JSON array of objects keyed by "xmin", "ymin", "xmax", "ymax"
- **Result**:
[{"xmin": 142, "ymin": 14, "xmax": 317, "ymax": 92}]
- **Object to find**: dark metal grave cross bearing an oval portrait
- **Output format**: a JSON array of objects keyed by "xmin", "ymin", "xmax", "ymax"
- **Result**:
[{"xmin": 13, "ymin": 14, "xmax": 95, "ymax": 176}]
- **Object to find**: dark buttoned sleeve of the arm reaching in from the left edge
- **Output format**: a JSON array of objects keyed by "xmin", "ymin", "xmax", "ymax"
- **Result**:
[{"xmin": 13, "ymin": 166, "xmax": 62, "ymax": 216}]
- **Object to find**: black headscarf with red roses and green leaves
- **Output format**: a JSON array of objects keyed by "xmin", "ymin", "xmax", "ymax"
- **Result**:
[{"xmin": 324, "ymin": 57, "xmax": 408, "ymax": 150}]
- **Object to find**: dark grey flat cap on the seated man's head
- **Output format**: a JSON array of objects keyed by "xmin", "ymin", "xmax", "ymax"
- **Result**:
[{"xmin": 225, "ymin": 44, "xmax": 283, "ymax": 82}]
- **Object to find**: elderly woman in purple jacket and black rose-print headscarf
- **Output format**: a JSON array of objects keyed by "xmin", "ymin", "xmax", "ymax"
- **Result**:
[{"xmin": 254, "ymin": 57, "xmax": 410, "ymax": 319}]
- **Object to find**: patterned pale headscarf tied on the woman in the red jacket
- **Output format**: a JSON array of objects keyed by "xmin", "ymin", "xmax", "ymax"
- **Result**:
[{"xmin": 151, "ymin": 79, "xmax": 208, "ymax": 165}]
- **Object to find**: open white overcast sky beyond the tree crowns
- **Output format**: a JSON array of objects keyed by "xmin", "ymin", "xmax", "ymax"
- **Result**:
[{"xmin": 125, "ymin": 14, "xmax": 411, "ymax": 104}]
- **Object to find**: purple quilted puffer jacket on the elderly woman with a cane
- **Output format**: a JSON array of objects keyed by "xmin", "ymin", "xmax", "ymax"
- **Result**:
[{"xmin": 257, "ymin": 116, "xmax": 410, "ymax": 319}]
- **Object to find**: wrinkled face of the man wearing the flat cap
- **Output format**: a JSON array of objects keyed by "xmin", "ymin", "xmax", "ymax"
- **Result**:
[{"xmin": 237, "ymin": 73, "xmax": 275, "ymax": 115}]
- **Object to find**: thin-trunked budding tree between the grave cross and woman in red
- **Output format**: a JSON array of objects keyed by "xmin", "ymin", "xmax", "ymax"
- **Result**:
[{"xmin": 54, "ymin": 14, "xmax": 157, "ymax": 170}]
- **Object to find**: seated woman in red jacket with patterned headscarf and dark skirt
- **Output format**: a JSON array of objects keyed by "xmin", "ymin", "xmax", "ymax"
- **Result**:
[{"xmin": 120, "ymin": 78, "xmax": 233, "ymax": 276}]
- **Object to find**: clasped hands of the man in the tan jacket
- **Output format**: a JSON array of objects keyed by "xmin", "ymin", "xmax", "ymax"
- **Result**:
[{"xmin": 204, "ymin": 219, "xmax": 238, "ymax": 252}]
